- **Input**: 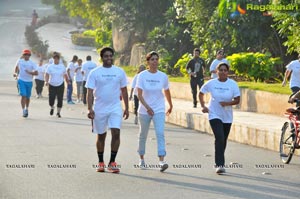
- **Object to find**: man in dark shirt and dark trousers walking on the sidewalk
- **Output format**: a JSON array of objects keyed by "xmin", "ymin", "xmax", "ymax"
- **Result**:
[{"xmin": 186, "ymin": 48, "xmax": 205, "ymax": 108}]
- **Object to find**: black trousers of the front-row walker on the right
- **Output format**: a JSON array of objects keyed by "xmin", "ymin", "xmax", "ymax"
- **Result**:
[{"xmin": 209, "ymin": 119, "xmax": 231, "ymax": 166}]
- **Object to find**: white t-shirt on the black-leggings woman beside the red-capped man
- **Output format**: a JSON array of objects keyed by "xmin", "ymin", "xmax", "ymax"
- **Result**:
[{"xmin": 46, "ymin": 64, "xmax": 67, "ymax": 86}]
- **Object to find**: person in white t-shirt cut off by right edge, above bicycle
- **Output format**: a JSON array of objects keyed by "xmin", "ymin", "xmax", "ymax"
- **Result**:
[{"xmin": 282, "ymin": 54, "xmax": 300, "ymax": 94}]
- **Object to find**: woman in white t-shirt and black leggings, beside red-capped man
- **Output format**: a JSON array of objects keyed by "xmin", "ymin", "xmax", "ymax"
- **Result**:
[{"xmin": 45, "ymin": 53, "xmax": 71, "ymax": 118}]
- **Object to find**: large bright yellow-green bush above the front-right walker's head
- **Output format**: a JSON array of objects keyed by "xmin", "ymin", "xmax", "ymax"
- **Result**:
[{"xmin": 227, "ymin": 53, "xmax": 280, "ymax": 82}]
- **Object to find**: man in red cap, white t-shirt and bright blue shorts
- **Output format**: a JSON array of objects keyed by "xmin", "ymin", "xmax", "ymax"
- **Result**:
[{"xmin": 15, "ymin": 49, "xmax": 38, "ymax": 117}]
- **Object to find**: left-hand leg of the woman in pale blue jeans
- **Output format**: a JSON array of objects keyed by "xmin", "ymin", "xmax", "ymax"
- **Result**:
[{"xmin": 138, "ymin": 114, "xmax": 151, "ymax": 159}]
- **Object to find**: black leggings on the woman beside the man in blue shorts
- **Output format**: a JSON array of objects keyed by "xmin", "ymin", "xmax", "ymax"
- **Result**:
[{"xmin": 49, "ymin": 83, "xmax": 65, "ymax": 108}]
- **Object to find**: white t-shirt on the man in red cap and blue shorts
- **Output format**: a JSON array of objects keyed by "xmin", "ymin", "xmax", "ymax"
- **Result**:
[{"xmin": 16, "ymin": 59, "xmax": 37, "ymax": 82}]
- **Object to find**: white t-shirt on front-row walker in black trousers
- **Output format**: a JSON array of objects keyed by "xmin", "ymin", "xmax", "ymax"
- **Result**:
[{"xmin": 200, "ymin": 79, "xmax": 240, "ymax": 123}]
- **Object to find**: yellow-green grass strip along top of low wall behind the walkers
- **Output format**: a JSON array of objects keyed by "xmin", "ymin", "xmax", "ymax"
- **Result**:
[{"xmin": 122, "ymin": 66, "xmax": 291, "ymax": 95}]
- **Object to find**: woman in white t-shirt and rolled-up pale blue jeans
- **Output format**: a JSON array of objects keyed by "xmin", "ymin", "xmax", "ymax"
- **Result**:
[{"xmin": 136, "ymin": 51, "xmax": 173, "ymax": 172}]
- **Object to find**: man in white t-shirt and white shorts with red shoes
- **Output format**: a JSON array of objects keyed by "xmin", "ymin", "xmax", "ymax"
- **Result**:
[{"xmin": 85, "ymin": 47, "xmax": 129, "ymax": 173}]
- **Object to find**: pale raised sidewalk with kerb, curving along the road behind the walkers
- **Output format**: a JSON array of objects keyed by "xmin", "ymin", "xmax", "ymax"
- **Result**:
[{"xmin": 37, "ymin": 23, "xmax": 297, "ymax": 152}]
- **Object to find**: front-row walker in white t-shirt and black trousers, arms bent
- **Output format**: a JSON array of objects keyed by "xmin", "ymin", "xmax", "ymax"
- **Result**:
[{"xmin": 199, "ymin": 63, "xmax": 240, "ymax": 174}]
